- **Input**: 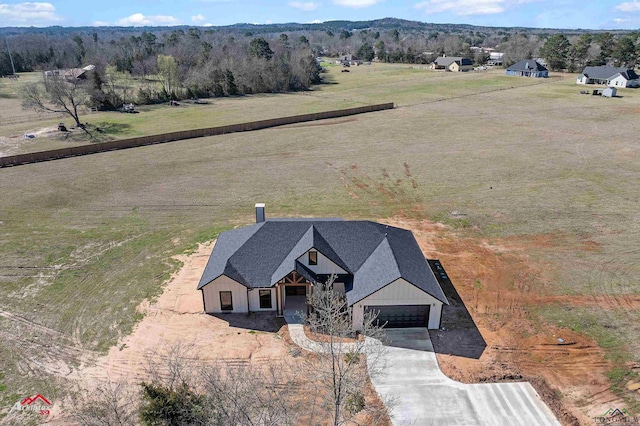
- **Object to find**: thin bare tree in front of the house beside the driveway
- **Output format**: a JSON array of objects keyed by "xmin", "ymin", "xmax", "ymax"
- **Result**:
[{"xmin": 305, "ymin": 277, "xmax": 386, "ymax": 426}]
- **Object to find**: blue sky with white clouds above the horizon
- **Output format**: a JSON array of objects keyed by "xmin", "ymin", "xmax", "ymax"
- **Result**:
[{"xmin": 0, "ymin": 0, "xmax": 640, "ymax": 29}]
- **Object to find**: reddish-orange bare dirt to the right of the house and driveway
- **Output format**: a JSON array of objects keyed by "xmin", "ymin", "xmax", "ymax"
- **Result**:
[{"xmin": 387, "ymin": 220, "xmax": 640, "ymax": 424}]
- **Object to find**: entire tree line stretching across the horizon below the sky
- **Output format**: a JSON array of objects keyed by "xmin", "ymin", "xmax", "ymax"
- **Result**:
[{"xmin": 5, "ymin": 20, "xmax": 640, "ymax": 115}]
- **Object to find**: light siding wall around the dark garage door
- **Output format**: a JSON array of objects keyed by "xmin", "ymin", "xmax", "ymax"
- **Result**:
[{"xmin": 351, "ymin": 278, "xmax": 442, "ymax": 329}]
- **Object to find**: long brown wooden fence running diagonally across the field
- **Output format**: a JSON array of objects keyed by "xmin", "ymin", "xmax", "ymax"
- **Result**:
[{"xmin": 0, "ymin": 103, "xmax": 393, "ymax": 168}]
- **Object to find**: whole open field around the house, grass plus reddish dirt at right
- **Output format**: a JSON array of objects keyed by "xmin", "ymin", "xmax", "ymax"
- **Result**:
[{"xmin": 0, "ymin": 64, "xmax": 640, "ymax": 424}]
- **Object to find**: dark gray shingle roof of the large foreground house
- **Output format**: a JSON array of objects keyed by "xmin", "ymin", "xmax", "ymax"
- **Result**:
[{"xmin": 198, "ymin": 219, "xmax": 448, "ymax": 305}]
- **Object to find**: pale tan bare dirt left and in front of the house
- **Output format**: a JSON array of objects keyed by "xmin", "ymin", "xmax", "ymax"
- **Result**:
[{"xmin": 67, "ymin": 244, "xmax": 289, "ymax": 385}]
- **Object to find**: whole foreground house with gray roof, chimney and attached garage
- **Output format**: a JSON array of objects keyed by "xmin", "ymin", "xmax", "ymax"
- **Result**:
[{"xmin": 198, "ymin": 204, "xmax": 448, "ymax": 329}]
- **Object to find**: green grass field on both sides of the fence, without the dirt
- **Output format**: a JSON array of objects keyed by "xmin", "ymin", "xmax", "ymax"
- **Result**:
[{"xmin": 0, "ymin": 64, "xmax": 640, "ymax": 420}]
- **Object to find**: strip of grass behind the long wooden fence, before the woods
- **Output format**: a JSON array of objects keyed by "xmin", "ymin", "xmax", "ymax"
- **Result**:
[{"xmin": 0, "ymin": 68, "xmax": 531, "ymax": 154}]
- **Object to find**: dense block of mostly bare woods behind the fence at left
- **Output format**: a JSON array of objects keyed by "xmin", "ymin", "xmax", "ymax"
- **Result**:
[{"xmin": 0, "ymin": 28, "xmax": 320, "ymax": 109}]
